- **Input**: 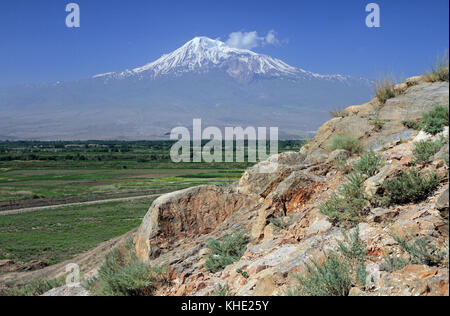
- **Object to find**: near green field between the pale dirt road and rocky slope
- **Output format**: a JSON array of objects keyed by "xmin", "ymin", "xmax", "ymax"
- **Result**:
[{"xmin": 0, "ymin": 199, "xmax": 152, "ymax": 264}]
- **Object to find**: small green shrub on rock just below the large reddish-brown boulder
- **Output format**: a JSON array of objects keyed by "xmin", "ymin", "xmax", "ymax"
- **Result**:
[{"xmin": 205, "ymin": 232, "xmax": 249, "ymax": 273}]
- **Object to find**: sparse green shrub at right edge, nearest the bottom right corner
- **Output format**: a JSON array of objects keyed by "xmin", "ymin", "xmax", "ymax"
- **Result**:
[{"xmin": 392, "ymin": 235, "xmax": 448, "ymax": 266}]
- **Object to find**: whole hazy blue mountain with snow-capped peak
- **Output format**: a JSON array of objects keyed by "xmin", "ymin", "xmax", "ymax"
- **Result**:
[{"xmin": 0, "ymin": 37, "xmax": 372, "ymax": 140}]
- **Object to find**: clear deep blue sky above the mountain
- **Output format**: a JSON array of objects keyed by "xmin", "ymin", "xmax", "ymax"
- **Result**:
[{"xmin": 0, "ymin": 0, "xmax": 449, "ymax": 85}]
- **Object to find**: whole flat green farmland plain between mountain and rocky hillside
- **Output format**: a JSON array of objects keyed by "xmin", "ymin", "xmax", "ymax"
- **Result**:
[{"xmin": 0, "ymin": 141, "xmax": 303, "ymax": 270}]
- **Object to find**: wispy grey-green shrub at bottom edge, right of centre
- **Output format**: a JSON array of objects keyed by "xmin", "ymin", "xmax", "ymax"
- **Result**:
[{"xmin": 298, "ymin": 254, "xmax": 352, "ymax": 296}]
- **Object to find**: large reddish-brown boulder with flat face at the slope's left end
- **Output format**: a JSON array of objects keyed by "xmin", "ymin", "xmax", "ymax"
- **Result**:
[{"xmin": 136, "ymin": 186, "xmax": 250, "ymax": 261}]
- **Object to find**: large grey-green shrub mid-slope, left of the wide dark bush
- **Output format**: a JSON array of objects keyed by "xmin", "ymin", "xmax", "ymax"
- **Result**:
[{"xmin": 319, "ymin": 173, "xmax": 367, "ymax": 227}]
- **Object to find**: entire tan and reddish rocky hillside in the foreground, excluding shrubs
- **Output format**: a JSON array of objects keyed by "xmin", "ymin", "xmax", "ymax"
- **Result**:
[{"xmin": 132, "ymin": 77, "xmax": 449, "ymax": 296}]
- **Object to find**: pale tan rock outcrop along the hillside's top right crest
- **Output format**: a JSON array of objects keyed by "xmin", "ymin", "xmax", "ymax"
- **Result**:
[{"xmin": 301, "ymin": 77, "xmax": 449, "ymax": 157}]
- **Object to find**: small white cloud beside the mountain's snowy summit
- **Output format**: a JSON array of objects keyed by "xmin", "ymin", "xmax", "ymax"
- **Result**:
[{"xmin": 226, "ymin": 30, "xmax": 280, "ymax": 49}]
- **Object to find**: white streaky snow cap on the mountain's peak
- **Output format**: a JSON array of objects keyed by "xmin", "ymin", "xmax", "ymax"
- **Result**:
[{"xmin": 93, "ymin": 37, "xmax": 364, "ymax": 81}]
